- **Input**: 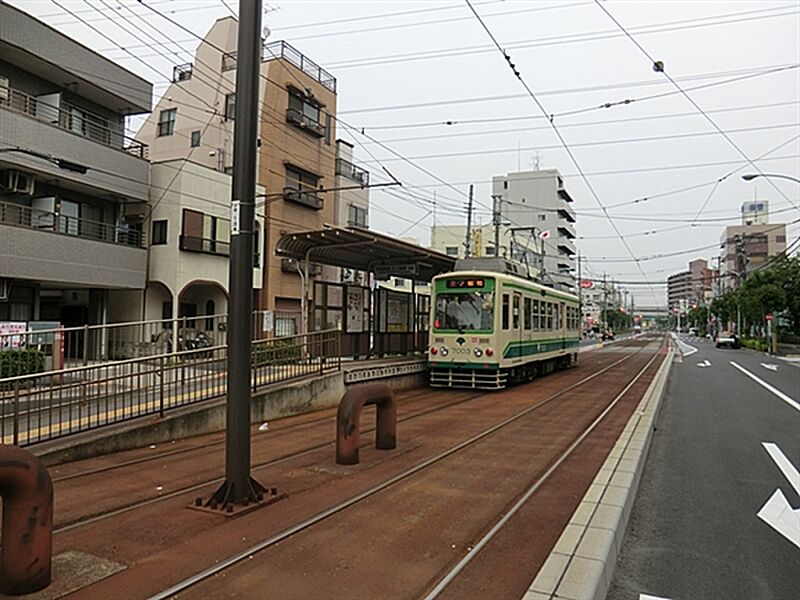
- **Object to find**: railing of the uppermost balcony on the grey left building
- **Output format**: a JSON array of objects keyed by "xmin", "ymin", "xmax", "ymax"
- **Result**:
[{"xmin": 0, "ymin": 86, "xmax": 149, "ymax": 159}]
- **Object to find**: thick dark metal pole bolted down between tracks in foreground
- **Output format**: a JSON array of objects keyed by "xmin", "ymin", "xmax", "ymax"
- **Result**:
[{"xmin": 206, "ymin": 0, "xmax": 266, "ymax": 512}]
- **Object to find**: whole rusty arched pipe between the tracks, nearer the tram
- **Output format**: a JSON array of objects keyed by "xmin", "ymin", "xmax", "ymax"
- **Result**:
[{"xmin": 336, "ymin": 383, "xmax": 397, "ymax": 465}]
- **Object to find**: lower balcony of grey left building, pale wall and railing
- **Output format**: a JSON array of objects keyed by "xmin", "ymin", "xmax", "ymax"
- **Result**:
[{"xmin": 0, "ymin": 202, "xmax": 147, "ymax": 289}]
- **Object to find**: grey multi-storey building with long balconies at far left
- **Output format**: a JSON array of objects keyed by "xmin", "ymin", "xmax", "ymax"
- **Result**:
[{"xmin": 0, "ymin": 2, "xmax": 152, "ymax": 326}]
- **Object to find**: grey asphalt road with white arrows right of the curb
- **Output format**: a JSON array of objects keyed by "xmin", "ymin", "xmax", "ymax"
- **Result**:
[{"xmin": 607, "ymin": 336, "xmax": 800, "ymax": 600}]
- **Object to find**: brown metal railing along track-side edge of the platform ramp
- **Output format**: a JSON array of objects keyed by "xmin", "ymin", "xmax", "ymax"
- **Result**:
[{"xmin": 0, "ymin": 330, "xmax": 341, "ymax": 446}]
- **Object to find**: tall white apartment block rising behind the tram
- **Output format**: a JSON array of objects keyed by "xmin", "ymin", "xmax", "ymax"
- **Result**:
[{"xmin": 492, "ymin": 169, "xmax": 577, "ymax": 288}]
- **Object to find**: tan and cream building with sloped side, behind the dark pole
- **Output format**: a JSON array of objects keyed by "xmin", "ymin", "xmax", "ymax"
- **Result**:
[{"xmin": 137, "ymin": 17, "xmax": 336, "ymax": 330}]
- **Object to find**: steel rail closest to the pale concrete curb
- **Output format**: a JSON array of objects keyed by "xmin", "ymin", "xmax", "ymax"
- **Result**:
[{"xmin": 418, "ymin": 346, "xmax": 661, "ymax": 600}]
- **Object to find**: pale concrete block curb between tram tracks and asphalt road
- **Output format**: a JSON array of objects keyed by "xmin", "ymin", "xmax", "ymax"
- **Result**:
[{"xmin": 522, "ymin": 345, "xmax": 675, "ymax": 600}]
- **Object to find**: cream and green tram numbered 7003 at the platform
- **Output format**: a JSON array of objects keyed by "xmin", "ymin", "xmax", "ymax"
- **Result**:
[{"xmin": 428, "ymin": 271, "xmax": 580, "ymax": 389}]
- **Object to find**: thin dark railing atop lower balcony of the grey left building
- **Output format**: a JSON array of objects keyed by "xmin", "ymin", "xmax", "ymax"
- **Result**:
[{"xmin": 0, "ymin": 202, "xmax": 144, "ymax": 248}]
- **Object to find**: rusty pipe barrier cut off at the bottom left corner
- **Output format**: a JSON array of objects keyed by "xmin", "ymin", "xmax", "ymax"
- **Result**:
[{"xmin": 0, "ymin": 444, "xmax": 53, "ymax": 596}]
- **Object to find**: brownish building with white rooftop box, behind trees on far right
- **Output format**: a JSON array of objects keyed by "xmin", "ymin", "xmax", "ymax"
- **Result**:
[{"xmin": 720, "ymin": 201, "xmax": 786, "ymax": 292}]
